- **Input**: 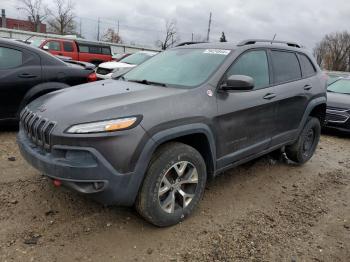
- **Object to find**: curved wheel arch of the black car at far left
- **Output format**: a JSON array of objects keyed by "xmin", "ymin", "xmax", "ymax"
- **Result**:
[{"xmin": 17, "ymin": 82, "xmax": 70, "ymax": 115}]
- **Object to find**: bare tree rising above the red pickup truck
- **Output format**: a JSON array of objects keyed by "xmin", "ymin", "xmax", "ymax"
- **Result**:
[{"xmin": 48, "ymin": 0, "xmax": 76, "ymax": 35}]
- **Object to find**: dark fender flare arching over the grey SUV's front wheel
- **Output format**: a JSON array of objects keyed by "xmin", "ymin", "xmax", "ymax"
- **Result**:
[{"xmin": 130, "ymin": 123, "xmax": 216, "ymax": 205}]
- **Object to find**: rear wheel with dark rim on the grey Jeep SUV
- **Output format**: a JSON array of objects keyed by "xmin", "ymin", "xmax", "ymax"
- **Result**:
[{"xmin": 286, "ymin": 117, "xmax": 321, "ymax": 165}]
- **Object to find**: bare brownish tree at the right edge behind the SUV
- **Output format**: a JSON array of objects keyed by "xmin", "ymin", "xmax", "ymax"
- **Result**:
[{"xmin": 314, "ymin": 31, "xmax": 350, "ymax": 71}]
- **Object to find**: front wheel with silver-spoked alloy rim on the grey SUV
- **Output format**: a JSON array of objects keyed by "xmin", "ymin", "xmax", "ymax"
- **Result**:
[{"xmin": 135, "ymin": 142, "xmax": 207, "ymax": 227}]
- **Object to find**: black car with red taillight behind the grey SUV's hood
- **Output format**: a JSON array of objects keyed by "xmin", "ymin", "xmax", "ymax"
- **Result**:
[{"xmin": 0, "ymin": 38, "xmax": 96, "ymax": 122}]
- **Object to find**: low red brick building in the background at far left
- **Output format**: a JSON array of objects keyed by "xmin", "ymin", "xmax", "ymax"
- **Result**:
[{"xmin": 0, "ymin": 9, "xmax": 46, "ymax": 33}]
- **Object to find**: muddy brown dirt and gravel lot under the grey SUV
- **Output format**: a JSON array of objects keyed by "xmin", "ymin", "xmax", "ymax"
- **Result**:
[{"xmin": 0, "ymin": 132, "xmax": 350, "ymax": 261}]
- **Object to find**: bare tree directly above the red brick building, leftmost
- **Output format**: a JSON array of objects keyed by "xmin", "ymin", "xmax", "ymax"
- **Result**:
[{"xmin": 17, "ymin": 0, "xmax": 47, "ymax": 31}]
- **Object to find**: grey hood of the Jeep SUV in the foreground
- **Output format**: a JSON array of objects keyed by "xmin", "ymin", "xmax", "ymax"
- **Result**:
[{"xmin": 28, "ymin": 79, "xmax": 186, "ymax": 130}]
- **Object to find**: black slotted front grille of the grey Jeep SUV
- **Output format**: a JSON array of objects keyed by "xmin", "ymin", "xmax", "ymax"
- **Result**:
[{"xmin": 20, "ymin": 108, "xmax": 55, "ymax": 151}]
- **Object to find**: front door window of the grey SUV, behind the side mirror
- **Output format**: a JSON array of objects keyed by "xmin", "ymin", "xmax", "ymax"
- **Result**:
[{"xmin": 226, "ymin": 50, "xmax": 270, "ymax": 89}]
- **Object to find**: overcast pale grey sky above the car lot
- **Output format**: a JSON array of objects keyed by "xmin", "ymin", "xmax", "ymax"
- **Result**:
[{"xmin": 0, "ymin": 0, "xmax": 350, "ymax": 49}]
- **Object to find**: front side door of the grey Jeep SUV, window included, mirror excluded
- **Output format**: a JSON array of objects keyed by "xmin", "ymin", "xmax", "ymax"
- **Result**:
[{"xmin": 216, "ymin": 49, "xmax": 277, "ymax": 168}]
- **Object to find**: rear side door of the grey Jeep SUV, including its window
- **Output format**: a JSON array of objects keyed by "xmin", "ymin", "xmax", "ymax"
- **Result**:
[{"xmin": 269, "ymin": 49, "xmax": 308, "ymax": 146}]
